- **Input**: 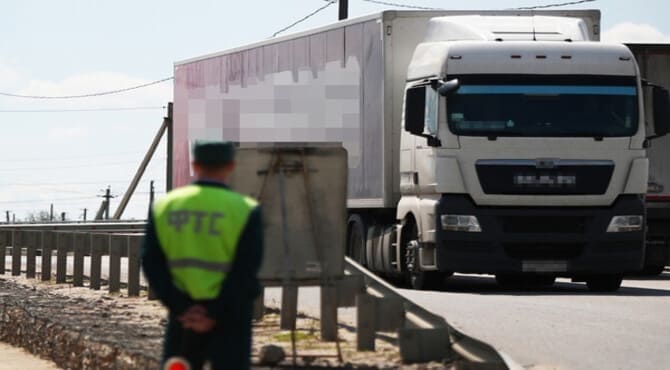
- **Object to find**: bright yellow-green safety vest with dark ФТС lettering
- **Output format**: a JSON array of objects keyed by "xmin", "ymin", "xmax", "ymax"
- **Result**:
[{"xmin": 153, "ymin": 185, "xmax": 257, "ymax": 300}]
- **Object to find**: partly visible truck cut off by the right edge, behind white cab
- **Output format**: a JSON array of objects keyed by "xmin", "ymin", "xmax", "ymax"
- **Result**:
[{"xmin": 627, "ymin": 44, "xmax": 670, "ymax": 275}]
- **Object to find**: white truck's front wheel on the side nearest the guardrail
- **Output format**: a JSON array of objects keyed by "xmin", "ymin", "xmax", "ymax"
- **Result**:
[{"xmin": 402, "ymin": 219, "xmax": 446, "ymax": 290}]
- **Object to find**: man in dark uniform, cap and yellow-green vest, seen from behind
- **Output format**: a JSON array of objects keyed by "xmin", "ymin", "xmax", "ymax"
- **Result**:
[{"xmin": 142, "ymin": 141, "xmax": 263, "ymax": 370}]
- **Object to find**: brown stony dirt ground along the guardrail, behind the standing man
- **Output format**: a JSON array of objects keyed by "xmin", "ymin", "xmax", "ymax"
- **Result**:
[{"xmin": 0, "ymin": 276, "xmax": 454, "ymax": 369}]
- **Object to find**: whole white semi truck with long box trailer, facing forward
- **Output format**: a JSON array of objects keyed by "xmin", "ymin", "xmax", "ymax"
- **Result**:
[{"xmin": 170, "ymin": 10, "xmax": 670, "ymax": 291}]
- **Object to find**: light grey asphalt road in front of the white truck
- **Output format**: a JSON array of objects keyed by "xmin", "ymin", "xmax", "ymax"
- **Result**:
[{"xmin": 403, "ymin": 272, "xmax": 670, "ymax": 370}]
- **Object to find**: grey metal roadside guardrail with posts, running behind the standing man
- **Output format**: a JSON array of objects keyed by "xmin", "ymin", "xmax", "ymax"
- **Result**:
[{"xmin": 0, "ymin": 221, "xmax": 510, "ymax": 370}]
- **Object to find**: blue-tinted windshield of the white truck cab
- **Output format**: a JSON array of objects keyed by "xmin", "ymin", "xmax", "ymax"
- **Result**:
[{"xmin": 447, "ymin": 76, "xmax": 638, "ymax": 137}]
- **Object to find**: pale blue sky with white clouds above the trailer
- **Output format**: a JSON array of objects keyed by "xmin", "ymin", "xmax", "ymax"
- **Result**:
[{"xmin": 0, "ymin": 0, "xmax": 670, "ymax": 222}]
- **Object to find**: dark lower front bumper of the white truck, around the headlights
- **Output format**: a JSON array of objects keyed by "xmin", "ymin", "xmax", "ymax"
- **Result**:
[{"xmin": 435, "ymin": 194, "xmax": 645, "ymax": 276}]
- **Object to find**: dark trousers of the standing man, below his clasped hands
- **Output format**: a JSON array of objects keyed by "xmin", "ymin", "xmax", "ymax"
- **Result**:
[{"xmin": 163, "ymin": 302, "xmax": 253, "ymax": 370}]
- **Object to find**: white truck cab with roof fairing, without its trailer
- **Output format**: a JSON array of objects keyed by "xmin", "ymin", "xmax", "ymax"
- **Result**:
[{"xmin": 397, "ymin": 15, "xmax": 670, "ymax": 290}]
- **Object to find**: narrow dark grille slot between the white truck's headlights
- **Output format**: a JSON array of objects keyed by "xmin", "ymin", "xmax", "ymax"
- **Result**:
[{"xmin": 500, "ymin": 216, "xmax": 586, "ymax": 234}]
